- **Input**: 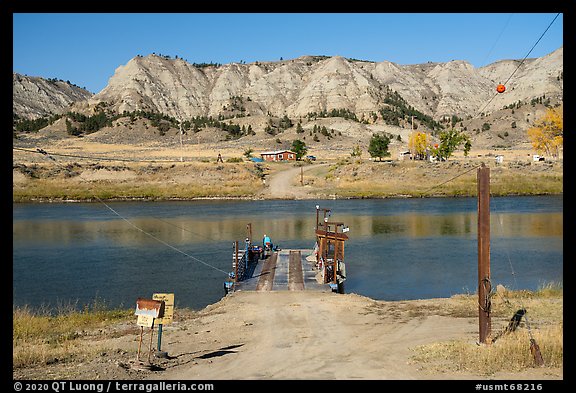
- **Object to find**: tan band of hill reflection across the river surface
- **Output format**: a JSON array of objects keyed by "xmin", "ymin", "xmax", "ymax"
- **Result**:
[{"xmin": 13, "ymin": 213, "xmax": 563, "ymax": 246}]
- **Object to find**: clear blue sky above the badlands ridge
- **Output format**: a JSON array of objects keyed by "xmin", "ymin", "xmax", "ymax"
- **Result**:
[{"xmin": 13, "ymin": 13, "xmax": 563, "ymax": 93}]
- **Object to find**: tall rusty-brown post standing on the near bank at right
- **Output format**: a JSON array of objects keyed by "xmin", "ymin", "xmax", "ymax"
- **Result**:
[{"xmin": 478, "ymin": 163, "xmax": 492, "ymax": 344}]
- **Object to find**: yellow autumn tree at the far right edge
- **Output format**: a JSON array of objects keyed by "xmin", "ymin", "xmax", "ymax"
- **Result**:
[{"xmin": 528, "ymin": 105, "xmax": 564, "ymax": 158}]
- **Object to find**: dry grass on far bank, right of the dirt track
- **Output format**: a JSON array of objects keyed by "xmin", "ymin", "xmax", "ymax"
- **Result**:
[{"xmin": 316, "ymin": 160, "xmax": 563, "ymax": 198}]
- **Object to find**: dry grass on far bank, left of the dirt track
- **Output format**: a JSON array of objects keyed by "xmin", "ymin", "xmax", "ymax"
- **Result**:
[{"xmin": 12, "ymin": 162, "xmax": 262, "ymax": 202}]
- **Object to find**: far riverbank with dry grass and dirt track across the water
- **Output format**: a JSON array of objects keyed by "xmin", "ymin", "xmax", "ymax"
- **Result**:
[{"xmin": 12, "ymin": 153, "xmax": 563, "ymax": 202}]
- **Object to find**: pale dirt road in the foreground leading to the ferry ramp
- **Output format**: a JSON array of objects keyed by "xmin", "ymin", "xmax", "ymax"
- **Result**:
[{"xmin": 142, "ymin": 290, "xmax": 557, "ymax": 380}]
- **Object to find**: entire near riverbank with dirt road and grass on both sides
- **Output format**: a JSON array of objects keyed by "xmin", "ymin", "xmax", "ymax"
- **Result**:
[{"xmin": 13, "ymin": 288, "xmax": 563, "ymax": 380}]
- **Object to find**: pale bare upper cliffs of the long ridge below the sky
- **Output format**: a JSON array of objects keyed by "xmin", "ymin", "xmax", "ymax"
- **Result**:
[{"xmin": 85, "ymin": 48, "xmax": 563, "ymax": 119}]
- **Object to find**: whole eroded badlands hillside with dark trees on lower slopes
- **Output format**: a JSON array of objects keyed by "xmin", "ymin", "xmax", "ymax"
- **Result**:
[{"xmin": 13, "ymin": 47, "xmax": 563, "ymax": 154}]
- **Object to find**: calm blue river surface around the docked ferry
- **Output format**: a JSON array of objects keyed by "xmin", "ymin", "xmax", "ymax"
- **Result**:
[{"xmin": 12, "ymin": 196, "xmax": 563, "ymax": 309}]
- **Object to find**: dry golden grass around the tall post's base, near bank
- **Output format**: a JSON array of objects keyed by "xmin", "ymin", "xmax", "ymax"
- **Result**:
[{"xmin": 412, "ymin": 283, "xmax": 564, "ymax": 376}]
